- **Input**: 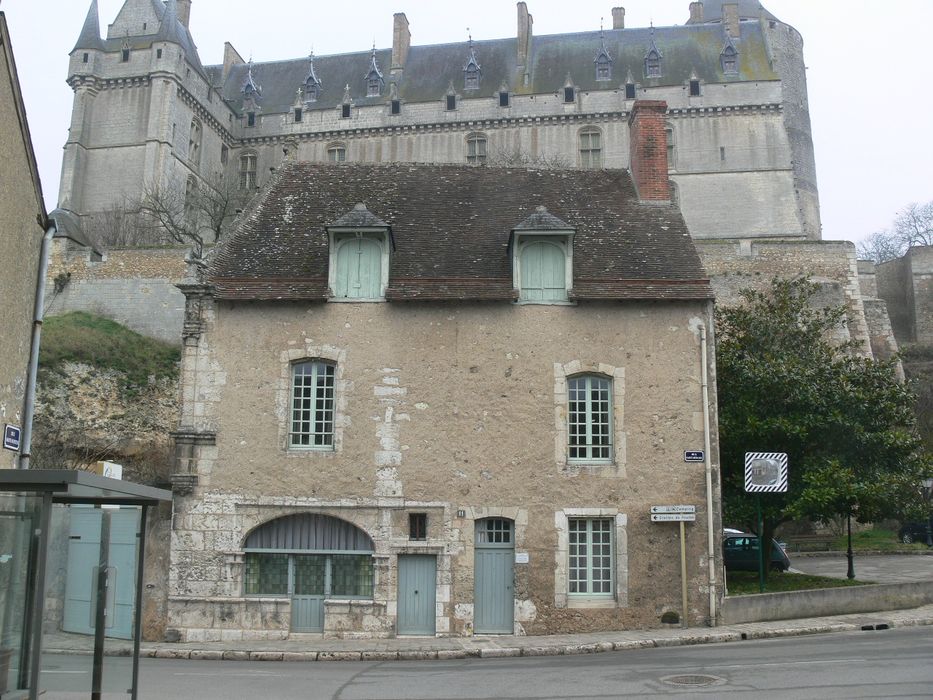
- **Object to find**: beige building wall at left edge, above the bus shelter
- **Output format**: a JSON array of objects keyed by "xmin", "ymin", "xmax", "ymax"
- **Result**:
[{"xmin": 0, "ymin": 12, "xmax": 48, "ymax": 469}]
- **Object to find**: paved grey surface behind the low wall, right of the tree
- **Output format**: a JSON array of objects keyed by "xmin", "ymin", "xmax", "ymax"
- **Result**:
[{"xmin": 787, "ymin": 552, "xmax": 933, "ymax": 580}]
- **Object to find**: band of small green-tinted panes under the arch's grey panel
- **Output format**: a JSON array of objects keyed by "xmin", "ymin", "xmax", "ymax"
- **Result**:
[{"xmin": 244, "ymin": 552, "xmax": 373, "ymax": 598}]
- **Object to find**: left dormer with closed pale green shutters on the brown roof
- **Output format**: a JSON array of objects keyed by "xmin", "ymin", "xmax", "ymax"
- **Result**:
[{"xmin": 327, "ymin": 203, "xmax": 392, "ymax": 301}]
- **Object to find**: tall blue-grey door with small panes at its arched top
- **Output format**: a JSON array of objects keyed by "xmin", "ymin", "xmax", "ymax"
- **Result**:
[{"xmin": 473, "ymin": 518, "xmax": 515, "ymax": 634}]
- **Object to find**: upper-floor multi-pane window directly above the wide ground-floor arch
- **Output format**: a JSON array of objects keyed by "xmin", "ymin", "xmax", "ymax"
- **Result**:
[{"xmin": 288, "ymin": 360, "xmax": 336, "ymax": 450}]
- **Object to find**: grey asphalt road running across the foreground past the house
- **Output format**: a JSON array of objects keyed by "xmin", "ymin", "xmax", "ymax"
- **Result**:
[{"xmin": 38, "ymin": 627, "xmax": 933, "ymax": 700}]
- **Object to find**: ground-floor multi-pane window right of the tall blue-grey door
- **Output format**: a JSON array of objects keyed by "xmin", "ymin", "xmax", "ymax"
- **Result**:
[{"xmin": 567, "ymin": 518, "xmax": 614, "ymax": 597}]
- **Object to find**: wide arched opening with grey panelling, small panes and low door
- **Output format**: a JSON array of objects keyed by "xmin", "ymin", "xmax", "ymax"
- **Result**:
[{"xmin": 243, "ymin": 513, "xmax": 373, "ymax": 632}]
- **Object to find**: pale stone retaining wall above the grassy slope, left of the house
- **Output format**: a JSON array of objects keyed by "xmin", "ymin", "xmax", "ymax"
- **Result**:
[{"xmin": 46, "ymin": 238, "xmax": 188, "ymax": 343}]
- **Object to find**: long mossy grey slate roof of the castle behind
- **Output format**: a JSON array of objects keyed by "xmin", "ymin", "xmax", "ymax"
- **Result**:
[{"xmin": 206, "ymin": 15, "xmax": 778, "ymax": 114}]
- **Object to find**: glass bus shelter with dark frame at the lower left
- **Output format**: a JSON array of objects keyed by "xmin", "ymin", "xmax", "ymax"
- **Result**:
[{"xmin": 0, "ymin": 469, "xmax": 172, "ymax": 700}]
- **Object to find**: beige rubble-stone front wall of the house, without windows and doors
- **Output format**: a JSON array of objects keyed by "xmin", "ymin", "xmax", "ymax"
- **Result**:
[{"xmin": 169, "ymin": 298, "xmax": 722, "ymax": 640}]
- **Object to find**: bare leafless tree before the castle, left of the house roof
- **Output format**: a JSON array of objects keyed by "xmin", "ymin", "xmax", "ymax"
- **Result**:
[{"xmin": 139, "ymin": 176, "xmax": 251, "ymax": 260}]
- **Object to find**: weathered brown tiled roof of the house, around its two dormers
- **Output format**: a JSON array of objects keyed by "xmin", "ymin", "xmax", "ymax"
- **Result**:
[{"xmin": 208, "ymin": 163, "xmax": 713, "ymax": 301}]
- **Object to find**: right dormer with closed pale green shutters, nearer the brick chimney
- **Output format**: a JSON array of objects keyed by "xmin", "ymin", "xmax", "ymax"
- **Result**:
[{"xmin": 511, "ymin": 207, "xmax": 575, "ymax": 304}]
